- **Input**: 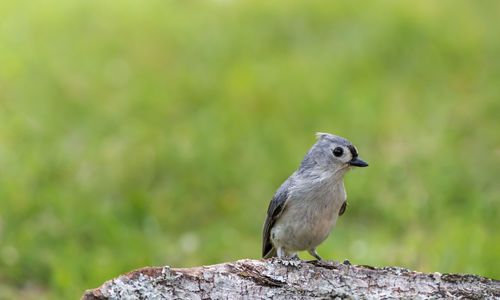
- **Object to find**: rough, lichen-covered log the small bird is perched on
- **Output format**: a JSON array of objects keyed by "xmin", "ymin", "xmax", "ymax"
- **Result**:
[{"xmin": 82, "ymin": 258, "xmax": 500, "ymax": 300}]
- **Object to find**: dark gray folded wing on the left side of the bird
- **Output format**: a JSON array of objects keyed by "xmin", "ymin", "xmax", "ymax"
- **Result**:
[{"xmin": 262, "ymin": 178, "xmax": 291, "ymax": 257}]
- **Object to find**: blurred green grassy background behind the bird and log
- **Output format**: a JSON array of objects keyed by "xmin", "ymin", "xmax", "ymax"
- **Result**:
[{"xmin": 0, "ymin": 0, "xmax": 500, "ymax": 299}]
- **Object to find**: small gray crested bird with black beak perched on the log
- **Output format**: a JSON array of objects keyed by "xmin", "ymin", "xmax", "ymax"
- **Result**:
[{"xmin": 262, "ymin": 132, "xmax": 368, "ymax": 260}]
